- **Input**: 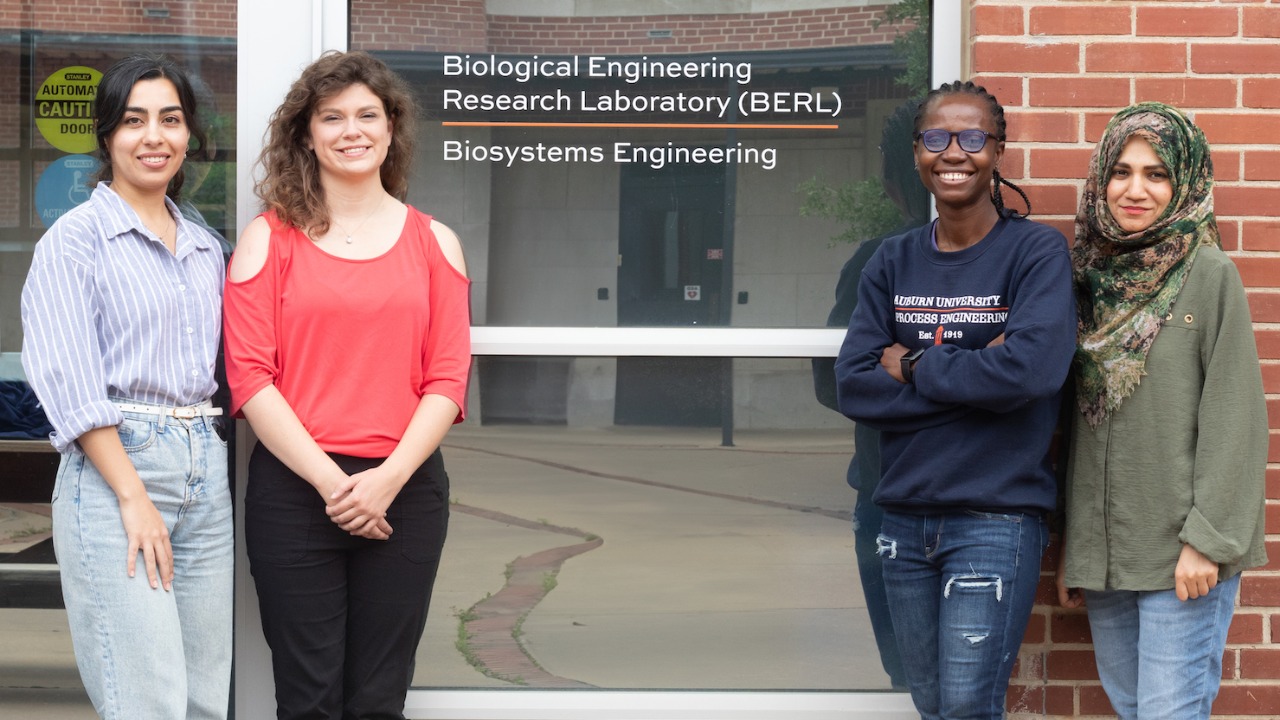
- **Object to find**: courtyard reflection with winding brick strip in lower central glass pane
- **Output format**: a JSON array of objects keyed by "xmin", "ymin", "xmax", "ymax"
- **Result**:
[{"xmin": 415, "ymin": 357, "xmax": 890, "ymax": 689}]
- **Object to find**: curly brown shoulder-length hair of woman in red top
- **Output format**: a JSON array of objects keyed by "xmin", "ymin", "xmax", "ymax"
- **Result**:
[{"xmin": 253, "ymin": 50, "xmax": 417, "ymax": 234}]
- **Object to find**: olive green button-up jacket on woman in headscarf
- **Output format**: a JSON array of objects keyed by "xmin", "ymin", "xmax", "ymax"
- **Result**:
[{"xmin": 1065, "ymin": 247, "xmax": 1267, "ymax": 591}]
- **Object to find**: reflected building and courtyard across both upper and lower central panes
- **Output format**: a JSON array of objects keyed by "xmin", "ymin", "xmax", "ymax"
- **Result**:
[{"xmin": 352, "ymin": 0, "xmax": 924, "ymax": 689}]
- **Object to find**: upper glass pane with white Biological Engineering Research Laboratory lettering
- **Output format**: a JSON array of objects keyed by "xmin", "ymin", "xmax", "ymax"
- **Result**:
[{"xmin": 352, "ymin": 0, "xmax": 927, "ymax": 328}]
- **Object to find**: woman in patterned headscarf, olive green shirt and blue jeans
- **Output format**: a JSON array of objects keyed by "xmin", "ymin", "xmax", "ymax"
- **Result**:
[{"xmin": 1057, "ymin": 102, "xmax": 1267, "ymax": 720}]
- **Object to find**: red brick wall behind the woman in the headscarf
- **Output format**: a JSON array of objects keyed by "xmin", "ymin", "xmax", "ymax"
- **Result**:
[{"xmin": 968, "ymin": 0, "xmax": 1280, "ymax": 717}]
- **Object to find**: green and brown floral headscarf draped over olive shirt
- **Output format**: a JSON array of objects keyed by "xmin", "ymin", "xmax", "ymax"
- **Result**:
[{"xmin": 1071, "ymin": 102, "xmax": 1221, "ymax": 427}]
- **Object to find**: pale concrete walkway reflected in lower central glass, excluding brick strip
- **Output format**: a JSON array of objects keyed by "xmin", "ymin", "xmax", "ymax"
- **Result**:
[{"xmin": 415, "ymin": 427, "xmax": 888, "ymax": 689}]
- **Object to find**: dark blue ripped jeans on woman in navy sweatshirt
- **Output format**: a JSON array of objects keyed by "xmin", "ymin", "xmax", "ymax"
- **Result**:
[{"xmin": 876, "ymin": 511, "xmax": 1048, "ymax": 720}]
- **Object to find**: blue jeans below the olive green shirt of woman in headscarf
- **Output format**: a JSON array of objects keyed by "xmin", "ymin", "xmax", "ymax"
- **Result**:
[{"xmin": 1084, "ymin": 575, "xmax": 1240, "ymax": 720}]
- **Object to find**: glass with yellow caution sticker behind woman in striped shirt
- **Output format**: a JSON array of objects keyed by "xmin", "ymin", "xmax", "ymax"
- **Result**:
[{"xmin": 0, "ymin": 33, "xmax": 236, "ymax": 352}]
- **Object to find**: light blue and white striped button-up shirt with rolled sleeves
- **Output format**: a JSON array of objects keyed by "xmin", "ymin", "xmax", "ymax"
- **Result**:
[{"xmin": 22, "ymin": 183, "xmax": 225, "ymax": 452}]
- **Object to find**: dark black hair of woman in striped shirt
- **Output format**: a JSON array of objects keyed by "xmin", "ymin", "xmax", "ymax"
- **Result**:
[{"xmin": 93, "ymin": 53, "xmax": 209, "ymax": 202}]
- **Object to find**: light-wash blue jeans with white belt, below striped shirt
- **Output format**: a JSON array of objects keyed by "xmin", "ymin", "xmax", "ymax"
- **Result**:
[{"xmin": 52, "ymin": 413, "xmax": 234, "ymax": 720}]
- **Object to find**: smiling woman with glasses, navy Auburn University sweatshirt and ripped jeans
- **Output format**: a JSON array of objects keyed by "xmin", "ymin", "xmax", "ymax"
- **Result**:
[{"xmin": 836, "ymin": 82, "xmax": 1075, "ymax": 719}]
